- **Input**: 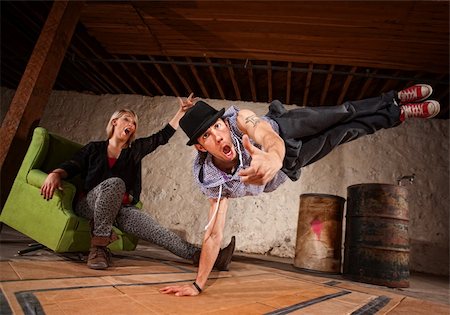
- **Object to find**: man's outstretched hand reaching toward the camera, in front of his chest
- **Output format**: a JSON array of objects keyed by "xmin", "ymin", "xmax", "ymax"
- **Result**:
[{"xmin": 239, "ymin": 135, "xmax": 283, "ymax": 185}]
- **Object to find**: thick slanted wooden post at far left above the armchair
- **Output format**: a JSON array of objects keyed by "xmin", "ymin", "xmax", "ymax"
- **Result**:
[{"xmin": 0, "ymin": 1, "xmax": 84, "ymax": 168}]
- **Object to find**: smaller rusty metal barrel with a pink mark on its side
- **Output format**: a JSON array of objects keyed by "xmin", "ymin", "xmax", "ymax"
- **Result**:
[{"xmin": 294, "ymin": 194, "xmax": 345, "ymax": 273}]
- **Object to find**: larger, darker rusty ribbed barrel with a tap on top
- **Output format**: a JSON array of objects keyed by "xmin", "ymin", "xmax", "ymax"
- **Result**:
[{"xmin": 343, "ymin": 183, "xmax": 409, "ymax": 288}]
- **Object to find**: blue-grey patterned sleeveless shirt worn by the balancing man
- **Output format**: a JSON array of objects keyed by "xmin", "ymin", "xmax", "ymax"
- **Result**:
[{"xmin": 194, "ymin": 106, "xmax": 288, "ymax": 198}]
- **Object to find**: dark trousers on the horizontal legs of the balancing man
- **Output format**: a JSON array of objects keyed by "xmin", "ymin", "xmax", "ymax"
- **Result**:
[{"xmin": 267, "ymin": 91, "xmax": 400, "ymax": 181}]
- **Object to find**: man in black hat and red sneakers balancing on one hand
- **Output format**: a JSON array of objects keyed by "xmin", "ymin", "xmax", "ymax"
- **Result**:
[{"xmin": 160, "ymin": 84, "xmax": 440, "ymax": 296}]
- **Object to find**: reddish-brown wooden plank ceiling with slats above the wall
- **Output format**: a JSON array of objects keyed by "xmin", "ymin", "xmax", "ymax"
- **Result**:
[{"xmin": 1, "ymin": 1, "xmax": 449, "ymax": 119}]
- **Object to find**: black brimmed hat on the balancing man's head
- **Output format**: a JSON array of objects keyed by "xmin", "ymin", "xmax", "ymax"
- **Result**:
[{"xmin": 180, "ymin": 101, "xmax": 225, "ymax": 145}]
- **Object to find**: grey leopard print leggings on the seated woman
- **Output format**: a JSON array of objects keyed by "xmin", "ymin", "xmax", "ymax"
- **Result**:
[{"xmin": 75, "ymin": 177, "xmax": 200, "ymax": 259}]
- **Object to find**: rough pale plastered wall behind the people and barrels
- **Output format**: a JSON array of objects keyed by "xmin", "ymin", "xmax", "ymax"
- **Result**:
[{"xmin": 2, "ymin": 89, "xmax": 450, "ymax": 275}]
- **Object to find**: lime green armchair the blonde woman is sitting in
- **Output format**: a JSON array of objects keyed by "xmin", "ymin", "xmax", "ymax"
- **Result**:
[{"xmin": 0, "ymin": 127, "xmax": 138, "ymax": 253}]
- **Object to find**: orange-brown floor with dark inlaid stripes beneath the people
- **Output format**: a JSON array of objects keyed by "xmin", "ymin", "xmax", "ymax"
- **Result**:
[{"xmin": 0, "ymin": 228, "xmax": 450, "ymax": 315}]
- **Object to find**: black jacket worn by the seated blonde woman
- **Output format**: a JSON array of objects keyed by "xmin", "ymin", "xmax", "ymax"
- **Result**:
[{"xmin": 59, "ymin": 124, "xmax": 175, "ymax": 204}]
